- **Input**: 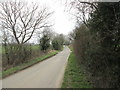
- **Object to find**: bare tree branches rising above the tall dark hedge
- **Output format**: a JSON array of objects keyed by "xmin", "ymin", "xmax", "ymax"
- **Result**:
[{"xmin": 65, "ymin": 0, "xmax": 97, "ymax": 27}]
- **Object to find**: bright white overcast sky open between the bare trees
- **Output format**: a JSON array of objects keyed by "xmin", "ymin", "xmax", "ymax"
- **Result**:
[{"xmin": 22, "ymin": 0, "xmax": 75, "ymax": 35}]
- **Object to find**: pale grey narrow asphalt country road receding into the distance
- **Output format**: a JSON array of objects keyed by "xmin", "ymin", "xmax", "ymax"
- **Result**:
[{"xmin": 2, "ymin": 47, "xmax": 70, "ymax": 88}]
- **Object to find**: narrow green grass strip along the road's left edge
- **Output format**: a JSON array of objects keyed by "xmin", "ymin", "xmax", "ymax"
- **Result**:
[{"xmin": 0, "ymin": 51, "xmax": 58, "ymax": 78}]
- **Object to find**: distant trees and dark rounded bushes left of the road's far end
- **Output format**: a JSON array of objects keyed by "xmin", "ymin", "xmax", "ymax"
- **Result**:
[{"xmin": 39, "ymin": 28, "xmax": 70, "ymax": 52}]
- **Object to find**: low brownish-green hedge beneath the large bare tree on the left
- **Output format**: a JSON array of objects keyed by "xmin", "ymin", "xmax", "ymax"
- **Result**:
[{"xmin": 2, "ymin": 44, "xmax": 43, "ymax": 71}]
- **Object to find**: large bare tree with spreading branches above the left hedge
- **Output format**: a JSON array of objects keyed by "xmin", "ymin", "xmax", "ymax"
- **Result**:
[{"xmin": 0, "ymin": 1, "xmax": 53, "ymax": 44}]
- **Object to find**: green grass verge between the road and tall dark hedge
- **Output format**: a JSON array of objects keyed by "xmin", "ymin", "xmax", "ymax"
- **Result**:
[{"xmin": 61, "ymin": 48, "xmax": 92, "ymax": 88}]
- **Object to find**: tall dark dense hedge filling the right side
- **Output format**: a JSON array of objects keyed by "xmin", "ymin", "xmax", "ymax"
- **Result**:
[{"xmin": 74, "ymin": 2, "xmax": 120, "ymax": 88}]
